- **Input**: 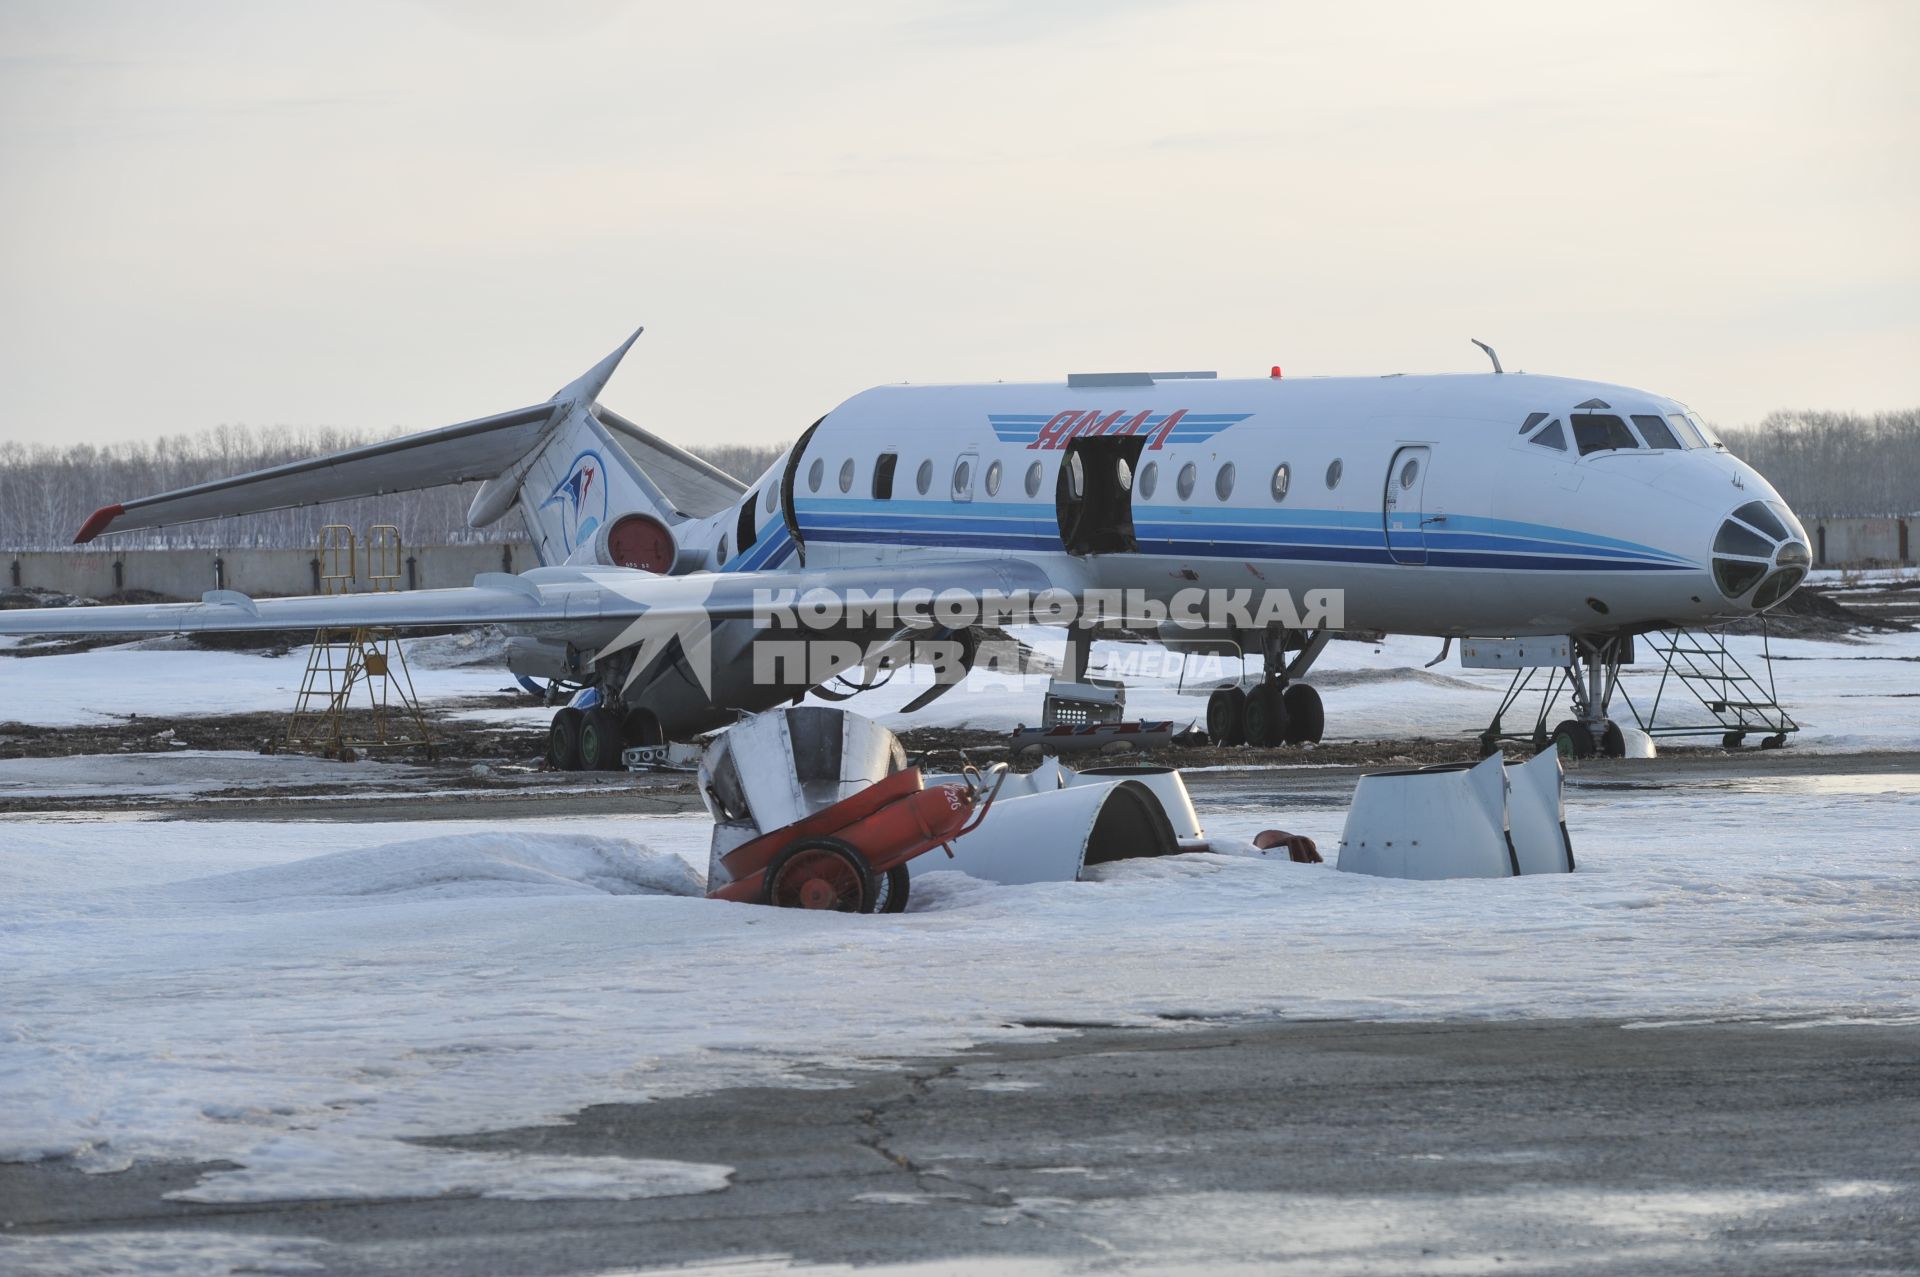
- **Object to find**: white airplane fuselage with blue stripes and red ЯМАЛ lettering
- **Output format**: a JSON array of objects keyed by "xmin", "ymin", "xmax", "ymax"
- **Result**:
[{"xmin": 680, "ymin": 374, "xmax": 1805, "ymax": 636}]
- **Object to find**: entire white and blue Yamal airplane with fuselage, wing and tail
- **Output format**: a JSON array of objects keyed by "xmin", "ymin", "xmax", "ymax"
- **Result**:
[{"xmin": 0, "ymin": 332, "xmax": 1811, "ymax": 770}]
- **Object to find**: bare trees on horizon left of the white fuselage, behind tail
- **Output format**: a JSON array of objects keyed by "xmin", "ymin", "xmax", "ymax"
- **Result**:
[{"xmin": 0, "ymin": 426, "xmax": 783, "ymax": 549}]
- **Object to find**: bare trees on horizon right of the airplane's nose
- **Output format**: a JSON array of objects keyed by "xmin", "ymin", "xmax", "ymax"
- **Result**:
[{"xmin": 1720, "ymin": 409, "xmax": 1920, "ymax": 518}]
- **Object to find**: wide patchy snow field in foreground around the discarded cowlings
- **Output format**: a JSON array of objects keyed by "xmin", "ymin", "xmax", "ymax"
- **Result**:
[{"xmin": 0, "ymin": 776, "xmax": 1920, "ymax": 1202}]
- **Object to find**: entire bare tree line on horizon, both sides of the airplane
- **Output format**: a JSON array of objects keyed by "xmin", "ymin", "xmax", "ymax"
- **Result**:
[{"xmin": 0, "ymin": 409, "xmax": 1920, "ymax": 549}]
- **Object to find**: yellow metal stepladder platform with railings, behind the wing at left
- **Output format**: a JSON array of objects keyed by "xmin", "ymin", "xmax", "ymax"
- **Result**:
[{"xmin": 284, "ymin": 524, "xmax": 434, "ymax": 762}]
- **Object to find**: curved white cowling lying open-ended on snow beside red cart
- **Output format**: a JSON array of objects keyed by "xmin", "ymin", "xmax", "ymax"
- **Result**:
[{"xmin": 906, "ymin": 778, "xmax": 1181, "ymax": 885}]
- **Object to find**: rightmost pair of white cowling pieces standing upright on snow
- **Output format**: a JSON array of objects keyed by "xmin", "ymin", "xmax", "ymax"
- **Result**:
[{"xmin": 1336, "ymin": 753, "xmax": 1572, "ymax": 879}]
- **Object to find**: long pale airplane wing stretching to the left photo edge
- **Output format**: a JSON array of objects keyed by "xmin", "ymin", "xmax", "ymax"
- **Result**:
[{"xmin": 0, "ymin": 559, "xmax": 1052, "ymax": 634}]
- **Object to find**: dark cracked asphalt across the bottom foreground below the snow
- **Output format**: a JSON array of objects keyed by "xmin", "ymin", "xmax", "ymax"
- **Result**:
[{"xmin": 0, "ymin": 1022, "xmax": 1920, "ymax": 1277}]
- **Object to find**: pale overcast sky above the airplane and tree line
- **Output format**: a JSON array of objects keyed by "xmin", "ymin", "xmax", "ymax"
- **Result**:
[{"xmin": 0, "ymin": 0, "xmax": 1920, "ymax": 446}]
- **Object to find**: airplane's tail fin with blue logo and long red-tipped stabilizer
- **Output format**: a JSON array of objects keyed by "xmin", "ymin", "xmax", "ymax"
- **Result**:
[{"xmin": 73, "ymin": 330, "xmax": 725, "ymax": 563}]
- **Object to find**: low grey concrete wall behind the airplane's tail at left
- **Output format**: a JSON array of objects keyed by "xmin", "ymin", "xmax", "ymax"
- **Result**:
[{"xmin": 0, "ymin": 542, "xmax": 538, "ymax": 599}]
